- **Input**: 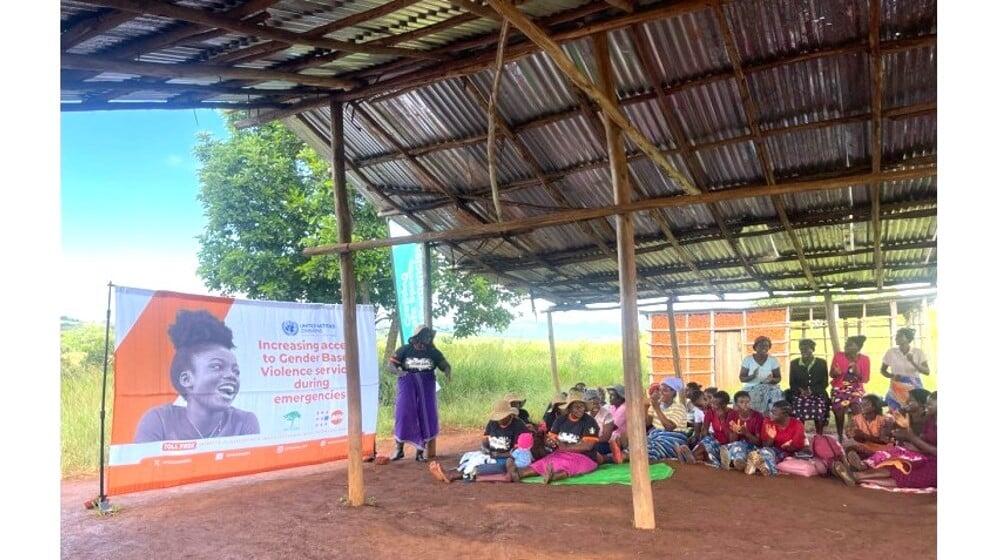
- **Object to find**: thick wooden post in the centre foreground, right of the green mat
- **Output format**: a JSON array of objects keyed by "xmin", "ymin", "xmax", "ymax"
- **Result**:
[{"xmin": 594, "ymin": 33, "xmax": 656, "ymax": 529}]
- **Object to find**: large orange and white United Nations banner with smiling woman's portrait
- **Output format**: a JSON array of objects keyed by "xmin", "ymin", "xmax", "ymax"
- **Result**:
[{"xmin": 107, "ymin": 287, "xmax": 378, "ymax": 494}]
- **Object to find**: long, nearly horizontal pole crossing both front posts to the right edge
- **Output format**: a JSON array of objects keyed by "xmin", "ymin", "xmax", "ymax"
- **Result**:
[{"xmin": 305, "ymin": 168, "xmax": 937, "ymax": 255}]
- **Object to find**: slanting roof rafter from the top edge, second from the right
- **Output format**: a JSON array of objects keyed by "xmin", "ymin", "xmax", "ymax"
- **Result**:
[{"xmin": 712, "ymin": 0, "xmax": 819, "ymax": 291}]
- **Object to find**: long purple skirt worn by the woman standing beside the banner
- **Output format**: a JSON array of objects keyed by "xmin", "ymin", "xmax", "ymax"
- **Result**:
[{"xmin": 395, "ymin": 372, "xmax": 438, "ymax": 449}]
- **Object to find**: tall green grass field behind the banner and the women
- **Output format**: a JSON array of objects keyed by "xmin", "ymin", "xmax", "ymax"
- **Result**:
[{"xmin": 61, "ymin": 310, "xmax": 937, "ymax": 476}]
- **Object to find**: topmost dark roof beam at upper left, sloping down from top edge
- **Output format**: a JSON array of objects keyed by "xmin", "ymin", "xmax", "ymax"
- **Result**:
[{"xmin": 74, "ymin": 0, "xmax": 441, "ymax": 60}]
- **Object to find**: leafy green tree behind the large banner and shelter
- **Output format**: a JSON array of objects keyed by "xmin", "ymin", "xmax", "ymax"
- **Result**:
[{"xmin": 195, "ymin": 113, "xmax": 523, "ymax": 337}]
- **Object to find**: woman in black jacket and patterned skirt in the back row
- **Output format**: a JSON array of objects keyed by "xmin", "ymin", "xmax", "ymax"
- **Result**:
[{"xmin": 788, "ymin": 338, "xmax": 830, "ymax": 435}]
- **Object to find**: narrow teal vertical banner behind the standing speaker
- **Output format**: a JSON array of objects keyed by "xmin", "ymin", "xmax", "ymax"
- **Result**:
[{"xmin": 389, "ymin": 220, "xmax": 429, "ymax": 344}]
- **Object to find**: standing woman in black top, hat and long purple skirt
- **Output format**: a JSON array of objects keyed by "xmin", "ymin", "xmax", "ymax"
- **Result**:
[{"xmin": 389, "ymin": 325, "xmax": 451, "ymax": 462}]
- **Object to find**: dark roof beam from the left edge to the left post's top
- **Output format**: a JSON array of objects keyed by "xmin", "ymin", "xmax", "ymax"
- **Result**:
[{"xmin": 61, "ymin": 54, "xmax": 357, "ymax": 89}]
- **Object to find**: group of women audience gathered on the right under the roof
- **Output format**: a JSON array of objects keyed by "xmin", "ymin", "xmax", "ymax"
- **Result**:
[{"xmin": 430, "ymin": 329, "xmax": 937, "ymax": 488}]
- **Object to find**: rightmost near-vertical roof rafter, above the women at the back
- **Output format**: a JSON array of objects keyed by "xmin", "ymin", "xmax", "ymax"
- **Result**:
[{"xmin": 868, "ymin": 0, "xmax": 888, "ymax": 290}]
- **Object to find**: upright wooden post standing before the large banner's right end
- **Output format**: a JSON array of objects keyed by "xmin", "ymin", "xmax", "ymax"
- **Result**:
[{"xmin": 330, "ymin": 100, "xmax": 365, "ymax": 506}]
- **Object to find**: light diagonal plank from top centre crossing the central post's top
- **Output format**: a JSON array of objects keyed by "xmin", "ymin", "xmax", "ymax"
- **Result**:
[{"xmin": 488, "ymin": 0, "xmax": 698, "ymax": 194}]
